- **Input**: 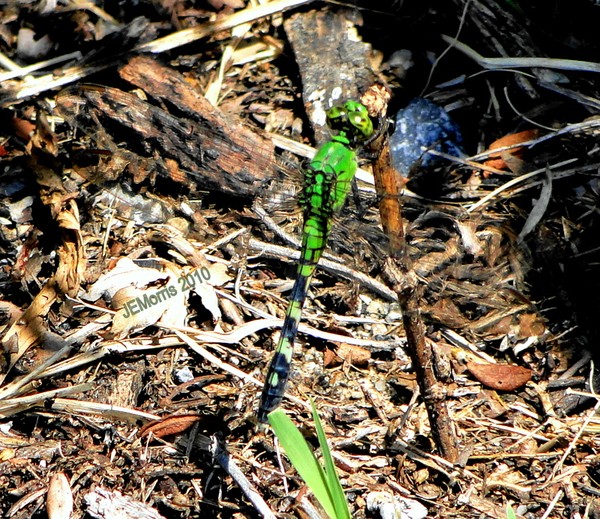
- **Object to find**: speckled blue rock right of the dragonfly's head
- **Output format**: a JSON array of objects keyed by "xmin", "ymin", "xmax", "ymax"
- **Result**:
[{"xmin": 390, "ymin": 97, "xmax": 464, "ymax": 176}]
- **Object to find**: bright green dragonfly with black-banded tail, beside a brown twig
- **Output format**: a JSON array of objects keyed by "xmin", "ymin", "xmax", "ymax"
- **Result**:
[{"xmin": 258, "ymin": 101, "xmax": 374, "ymax": 423}]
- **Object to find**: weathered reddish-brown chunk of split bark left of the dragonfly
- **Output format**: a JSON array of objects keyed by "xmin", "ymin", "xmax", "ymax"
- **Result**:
[{"xmin": 56, "ymin": 57, "xmax": 275, "ymax": 197}]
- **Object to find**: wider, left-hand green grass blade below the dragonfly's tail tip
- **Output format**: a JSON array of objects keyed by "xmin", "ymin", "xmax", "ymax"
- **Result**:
[{"xmin": 269, "ymin": 409, "xmax": 338, "ymax": 519}]
